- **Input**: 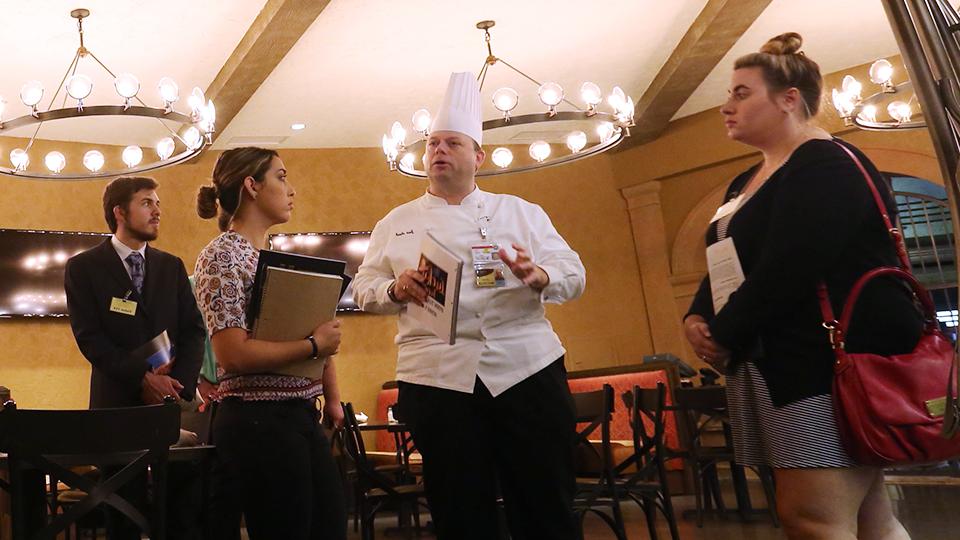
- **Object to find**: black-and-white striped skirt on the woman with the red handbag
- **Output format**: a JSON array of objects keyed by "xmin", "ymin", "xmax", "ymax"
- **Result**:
[{"xmin": 727, "ymin": 362, "xmax": 856, "ymax": 469}]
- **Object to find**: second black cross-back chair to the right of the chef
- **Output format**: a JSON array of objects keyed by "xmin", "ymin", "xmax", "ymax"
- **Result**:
[{"xmin": 614, "ymin": 383, "xmax": 680, "ymax": 540}]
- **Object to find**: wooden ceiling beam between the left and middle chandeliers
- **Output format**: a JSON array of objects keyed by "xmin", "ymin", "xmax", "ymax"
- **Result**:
[{"xmin": 204, "ymin": 0, "xmax": 330, "ymax": 138}]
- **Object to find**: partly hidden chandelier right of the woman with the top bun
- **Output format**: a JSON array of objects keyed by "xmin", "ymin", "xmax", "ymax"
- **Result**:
[{"xmin": 831, "ymin": 58, "xmax": 927, "ymax": 131}]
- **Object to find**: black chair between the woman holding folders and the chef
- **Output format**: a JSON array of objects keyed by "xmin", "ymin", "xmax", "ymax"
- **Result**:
[{"xmin": 342, "ymin": 403, "xmax": 429, "ymax": 540}]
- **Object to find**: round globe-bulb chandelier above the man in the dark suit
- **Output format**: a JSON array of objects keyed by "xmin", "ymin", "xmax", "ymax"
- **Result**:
[{"xmin": 0, "ymin": 9, "xmax": 216, "ymax": 180}]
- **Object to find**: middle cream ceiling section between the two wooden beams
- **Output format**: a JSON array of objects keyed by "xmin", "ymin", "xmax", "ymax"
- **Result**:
[{"xmin": 217, "ymin": 0, "xmax": 706, "ymax": 147}]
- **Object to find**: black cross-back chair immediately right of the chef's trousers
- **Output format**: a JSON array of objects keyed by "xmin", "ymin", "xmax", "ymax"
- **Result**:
[{"xmin": 573, "ymin": 384, "xmax": 627, "ymax": 540}]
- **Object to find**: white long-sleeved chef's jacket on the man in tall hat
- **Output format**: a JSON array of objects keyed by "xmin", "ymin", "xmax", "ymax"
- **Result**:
[{"xmin": 353, "ymin": 189, "xmax": 586, "ymax": 396}]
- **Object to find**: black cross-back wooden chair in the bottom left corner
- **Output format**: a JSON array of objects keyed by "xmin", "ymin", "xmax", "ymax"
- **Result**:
[{"xmin": 0, "ymin": 400, "xmax": 180, "ymax": 540}]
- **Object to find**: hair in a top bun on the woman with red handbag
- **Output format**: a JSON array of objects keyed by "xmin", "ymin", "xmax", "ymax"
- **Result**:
[{"xmin": 733, "ymin": 32, "xmax": 823, "ymax": 119}]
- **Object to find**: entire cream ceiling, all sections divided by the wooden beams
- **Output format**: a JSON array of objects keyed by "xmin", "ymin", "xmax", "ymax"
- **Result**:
[{"xmin": 0, "ymin": 0, "xmax": 897, "ymax": 152}]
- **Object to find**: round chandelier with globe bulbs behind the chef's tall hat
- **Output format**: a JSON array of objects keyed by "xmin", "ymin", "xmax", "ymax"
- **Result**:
[{"xmin": 381, "ymin": 21, "xmax": 634, "ymax": 178}]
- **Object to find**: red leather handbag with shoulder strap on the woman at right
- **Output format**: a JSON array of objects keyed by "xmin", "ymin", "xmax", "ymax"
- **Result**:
[{"xmin": 818, "ymin": 143, "xmax": 960, "ymax": 466}]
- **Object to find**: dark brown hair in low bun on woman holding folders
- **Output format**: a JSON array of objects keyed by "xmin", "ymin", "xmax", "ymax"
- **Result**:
[{"xmin": 197, "ymin": 146, "xmax": 279, "ymax": 231}]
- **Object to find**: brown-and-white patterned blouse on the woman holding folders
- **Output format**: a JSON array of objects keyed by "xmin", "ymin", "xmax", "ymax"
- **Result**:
[{"xmin": 194, "ymin": 231, "xmax": 323, "ymax": 401}]
